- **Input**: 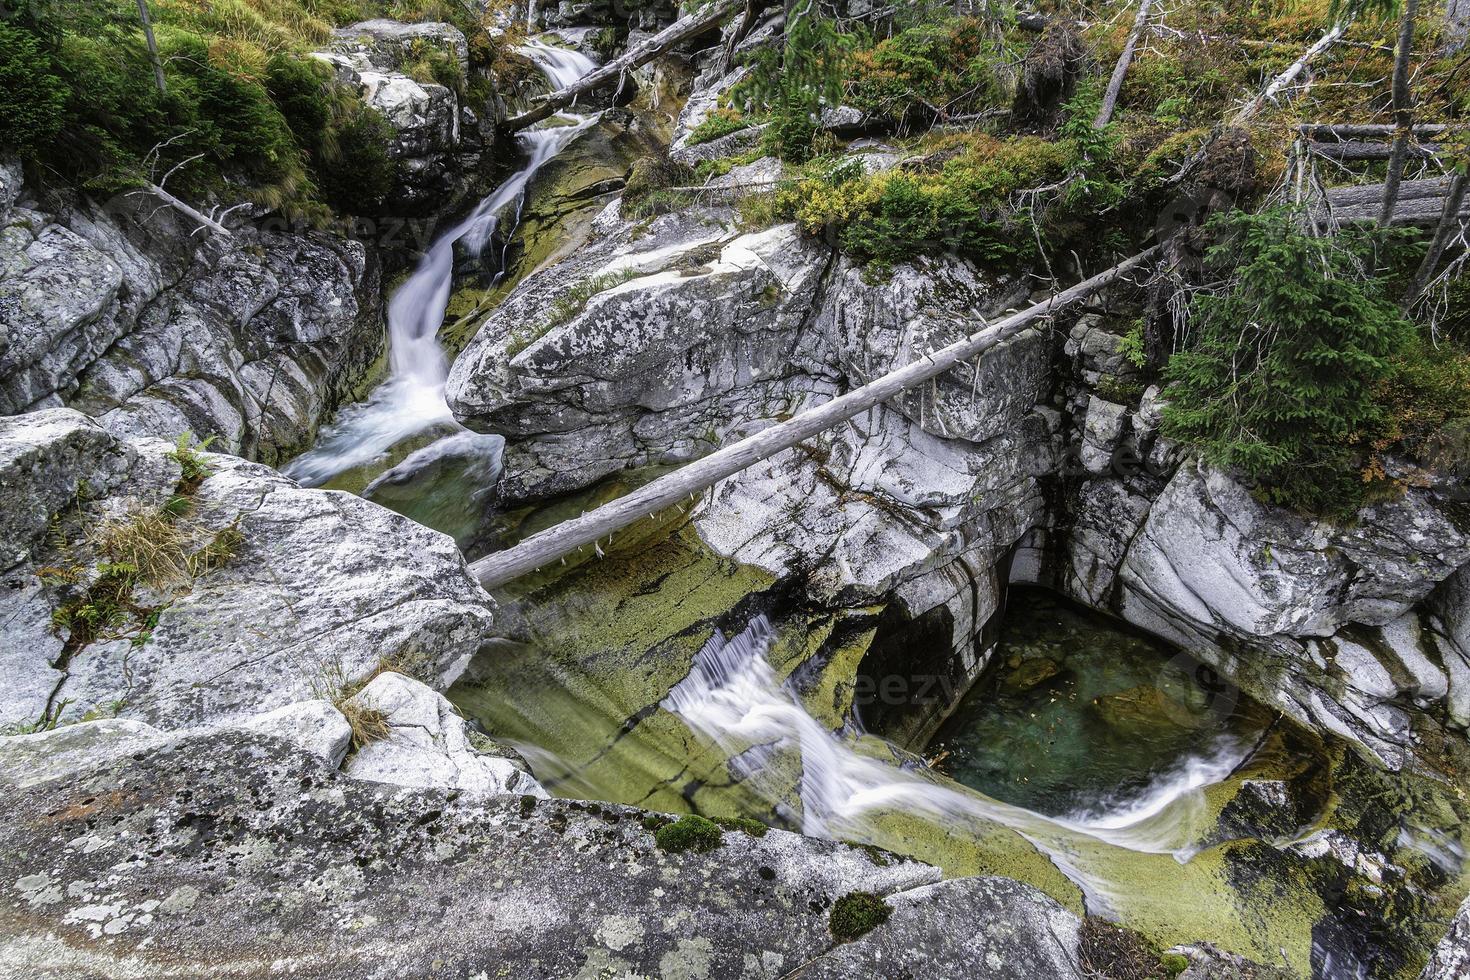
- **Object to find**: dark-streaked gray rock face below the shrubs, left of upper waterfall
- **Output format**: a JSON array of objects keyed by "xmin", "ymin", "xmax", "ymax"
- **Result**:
[{"xmin": 0, "ymin": 171, "xmax": 382, "ymax": 461}]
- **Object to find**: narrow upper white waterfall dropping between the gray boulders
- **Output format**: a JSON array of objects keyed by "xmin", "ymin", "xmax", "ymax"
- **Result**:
[{"xmin": 285, "ymin": 38, "xmax": 597, "ymax": 486}]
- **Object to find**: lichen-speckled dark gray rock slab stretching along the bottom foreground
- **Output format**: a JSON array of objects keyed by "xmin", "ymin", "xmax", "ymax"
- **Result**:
[{"xmin": 0, "ymin": 721, "xmax": 1078, "ymax": 977}]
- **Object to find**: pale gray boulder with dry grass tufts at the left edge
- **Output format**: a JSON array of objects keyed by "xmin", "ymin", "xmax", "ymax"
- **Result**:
[{"xmin": 0, "ymin": 410, "xmax": 490, "ymax": 727}]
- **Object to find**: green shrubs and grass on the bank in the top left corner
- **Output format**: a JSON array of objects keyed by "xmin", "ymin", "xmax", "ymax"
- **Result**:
[{"xmin": 0, "ymin": 0, "xmax": 495, "ymax": 220}]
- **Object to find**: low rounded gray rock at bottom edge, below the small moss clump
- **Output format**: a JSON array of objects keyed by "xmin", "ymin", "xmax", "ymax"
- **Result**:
[{"xmin": 800, "ymin": 877, "xmax": 1088, "ymax": 980}]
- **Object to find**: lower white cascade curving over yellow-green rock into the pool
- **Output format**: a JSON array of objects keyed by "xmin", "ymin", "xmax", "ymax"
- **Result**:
[{"xmin": 662, "ymin": 617, "xmax": 1244, "ymax": 911}]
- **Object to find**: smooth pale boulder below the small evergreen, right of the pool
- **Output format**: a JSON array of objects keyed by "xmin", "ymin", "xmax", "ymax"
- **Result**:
[{"xmin": 1116, "ymin": 464, "xmax": 1470, "ymax": 768}]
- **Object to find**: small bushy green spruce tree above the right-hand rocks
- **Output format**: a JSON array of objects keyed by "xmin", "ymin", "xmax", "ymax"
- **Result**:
[{"xmin": 1164, "ymin": 209, "xmax": 1414, "ymax": 516}]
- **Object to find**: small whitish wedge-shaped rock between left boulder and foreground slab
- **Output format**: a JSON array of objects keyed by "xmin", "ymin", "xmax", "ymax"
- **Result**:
[{"xmin": 343, "ymin": 671, "xmax": 547, "ymax": 798}]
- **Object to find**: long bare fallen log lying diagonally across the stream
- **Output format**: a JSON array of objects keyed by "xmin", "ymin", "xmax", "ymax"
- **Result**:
[{"xmin": 470, "ymin": 245, "xmax": 1158, "ymax": 588}]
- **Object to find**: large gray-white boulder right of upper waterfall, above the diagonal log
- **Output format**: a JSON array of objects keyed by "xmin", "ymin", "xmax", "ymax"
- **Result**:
[{"xmin": 447, "ymin": 215, "xmax": 823, "ymax": 501}]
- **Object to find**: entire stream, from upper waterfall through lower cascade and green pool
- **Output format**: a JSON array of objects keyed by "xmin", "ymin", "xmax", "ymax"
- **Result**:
[{"xmin": 277, "ymin": 40, "xmax": 1464, "ymax": 977}]
